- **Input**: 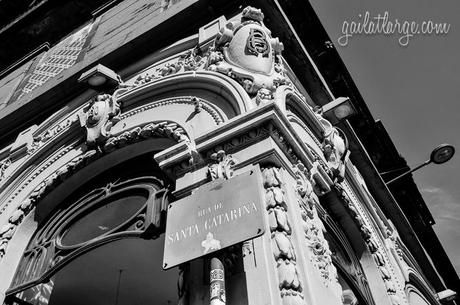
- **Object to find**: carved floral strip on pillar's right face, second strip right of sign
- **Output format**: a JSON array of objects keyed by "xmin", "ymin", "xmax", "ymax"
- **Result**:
[{"xmin": 293, "ymin": 162, "xmax": 342, "ymax": 295}]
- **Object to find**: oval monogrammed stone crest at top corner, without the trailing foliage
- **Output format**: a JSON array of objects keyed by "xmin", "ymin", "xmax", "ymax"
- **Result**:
[{"xmin": 206, "ymin": 6, "xmax": 288, "ymax": 103}]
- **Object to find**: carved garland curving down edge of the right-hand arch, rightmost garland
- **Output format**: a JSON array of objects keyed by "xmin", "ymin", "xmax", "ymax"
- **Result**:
[{"xmin": 335, "ymin": 183, "xmax": 401, "ymax": 305}]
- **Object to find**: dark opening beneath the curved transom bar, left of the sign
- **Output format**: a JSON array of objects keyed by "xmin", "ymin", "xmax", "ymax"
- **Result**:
[{"xmin": 17, "ymin": 237, "xmax": 178, "ymax": 305}]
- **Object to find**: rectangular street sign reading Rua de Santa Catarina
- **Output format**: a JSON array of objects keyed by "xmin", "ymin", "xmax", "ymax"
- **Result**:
[{"xmin": 163, "ymin": 167, "xmax": 265, "ymax": 269}]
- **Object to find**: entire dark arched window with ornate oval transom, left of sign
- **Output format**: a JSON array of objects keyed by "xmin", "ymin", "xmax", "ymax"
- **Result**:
[{"xmin": 5, "ymin": 153, "xmax": 180, "ymax": 305}]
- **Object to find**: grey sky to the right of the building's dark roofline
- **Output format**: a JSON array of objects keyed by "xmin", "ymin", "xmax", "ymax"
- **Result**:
[{"xmin": 310, "ymin": 0, "xmax": 460, "ymax": 274}]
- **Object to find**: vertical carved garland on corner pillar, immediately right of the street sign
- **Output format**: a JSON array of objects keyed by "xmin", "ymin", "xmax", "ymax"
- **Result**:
[{"xmin": 262, "ymin": 167, "xmax": 305, "ymax": 305}]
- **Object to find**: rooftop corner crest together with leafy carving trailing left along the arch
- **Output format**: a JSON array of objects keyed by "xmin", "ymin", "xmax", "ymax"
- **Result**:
[{"xmin": 126, "ymin": 7, "xmax": 290, "ymax": 105}]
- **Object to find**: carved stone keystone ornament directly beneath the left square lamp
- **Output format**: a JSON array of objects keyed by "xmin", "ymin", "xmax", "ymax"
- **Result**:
[{"xmin": 78, "ymin": 94, "xmax": 120, "ymax": 146}]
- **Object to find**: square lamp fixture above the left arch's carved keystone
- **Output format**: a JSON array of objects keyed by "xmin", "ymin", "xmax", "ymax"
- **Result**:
[{"xmin": 78, "ymin": 64, "xmax": 120, "ymax": 91}]
